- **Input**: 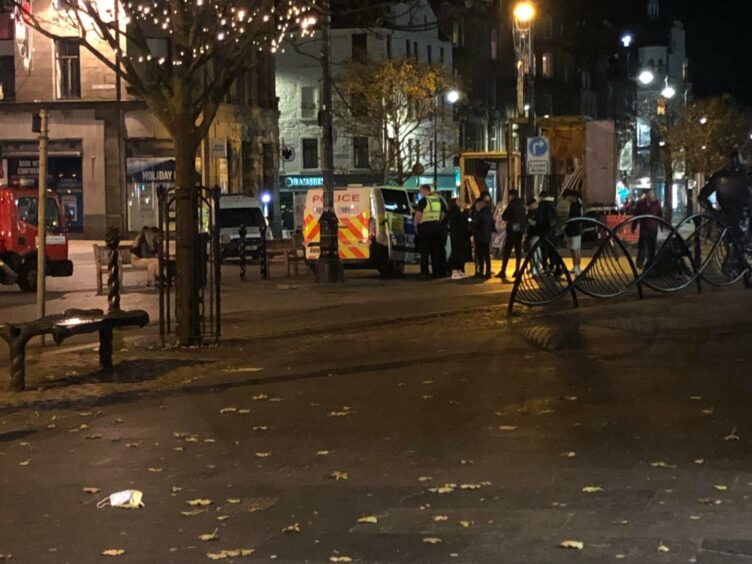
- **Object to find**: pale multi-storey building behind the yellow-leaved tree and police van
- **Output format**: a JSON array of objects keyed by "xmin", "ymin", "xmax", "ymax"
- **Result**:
[{"xmin": 276, "ymin": 1, "xmax": 456, "ymax": 229}]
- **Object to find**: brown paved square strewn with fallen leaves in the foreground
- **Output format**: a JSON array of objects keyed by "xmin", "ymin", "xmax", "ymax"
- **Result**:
[{"xmin": 0, "ymin": 240, "xmax": 752, "ymax": 564}]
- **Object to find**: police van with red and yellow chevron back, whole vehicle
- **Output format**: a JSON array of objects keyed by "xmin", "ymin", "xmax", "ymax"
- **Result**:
[{"xmin": 303, "ymin": 186, "xmax": 418, "ymax": 276}]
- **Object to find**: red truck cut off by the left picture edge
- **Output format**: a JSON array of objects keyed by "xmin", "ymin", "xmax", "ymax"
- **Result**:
[{"xmin": 0, "ymin": 186, "xmax": 73, "ymax": 292}]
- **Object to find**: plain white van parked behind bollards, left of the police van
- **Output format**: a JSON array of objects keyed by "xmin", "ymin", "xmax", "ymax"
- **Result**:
[{"xmin": 216, "ymin": 194, "xmax": 272, "ymax": 259}]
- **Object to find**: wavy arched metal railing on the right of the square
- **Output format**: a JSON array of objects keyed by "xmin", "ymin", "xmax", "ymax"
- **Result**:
[{"xmin": 508, "ymin": 213, "xmax": 752, "ymax": 314}]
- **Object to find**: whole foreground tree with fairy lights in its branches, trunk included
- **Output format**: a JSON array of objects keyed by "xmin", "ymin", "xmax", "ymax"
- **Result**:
[{"xmin": 22, "ymin": 0, "xmax": 313, "ymax": 345}]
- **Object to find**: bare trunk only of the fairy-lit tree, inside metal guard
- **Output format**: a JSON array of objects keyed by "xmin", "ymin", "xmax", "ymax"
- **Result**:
[{"xmin": 175, "ymin": 135, "xmax": 202, "ymax": 346}]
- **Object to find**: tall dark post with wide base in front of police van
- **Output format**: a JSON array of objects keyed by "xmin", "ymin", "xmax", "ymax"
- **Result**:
[{"xmin": 316, "ymin": 0, "xmax": 344, "ymax": 282}]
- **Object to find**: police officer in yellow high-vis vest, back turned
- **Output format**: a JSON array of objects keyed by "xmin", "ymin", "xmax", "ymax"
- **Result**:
[{"xmin": 415, "ymin": 184, "xmax": 447, "ymax": 278}]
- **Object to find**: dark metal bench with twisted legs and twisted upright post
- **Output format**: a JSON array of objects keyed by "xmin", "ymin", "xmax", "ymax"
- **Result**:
[{"xmin": 0, "ymin": 229, "xmax": 149, "ymax": 391}]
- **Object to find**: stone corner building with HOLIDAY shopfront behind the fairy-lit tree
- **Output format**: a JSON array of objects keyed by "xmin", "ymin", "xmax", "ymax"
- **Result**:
[{"xmin": 0, "ymin": 1, "xmax": 279, "ymax": 239}]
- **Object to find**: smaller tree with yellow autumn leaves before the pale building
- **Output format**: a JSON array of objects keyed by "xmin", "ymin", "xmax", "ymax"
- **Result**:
[{"xmin": 334, "ymin": 58, "xmax": 454, "ymax": 186}]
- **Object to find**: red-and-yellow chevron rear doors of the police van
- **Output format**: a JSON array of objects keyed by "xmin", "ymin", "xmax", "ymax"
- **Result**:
[{"xmin": 303, "ymin": 188, "xmax": 371, "ymax": 261}]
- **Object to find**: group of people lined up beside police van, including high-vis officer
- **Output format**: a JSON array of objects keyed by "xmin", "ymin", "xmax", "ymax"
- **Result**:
[{"xmin": 415, "ymin": 185, "xmax": 583, "ymax": 282}]
